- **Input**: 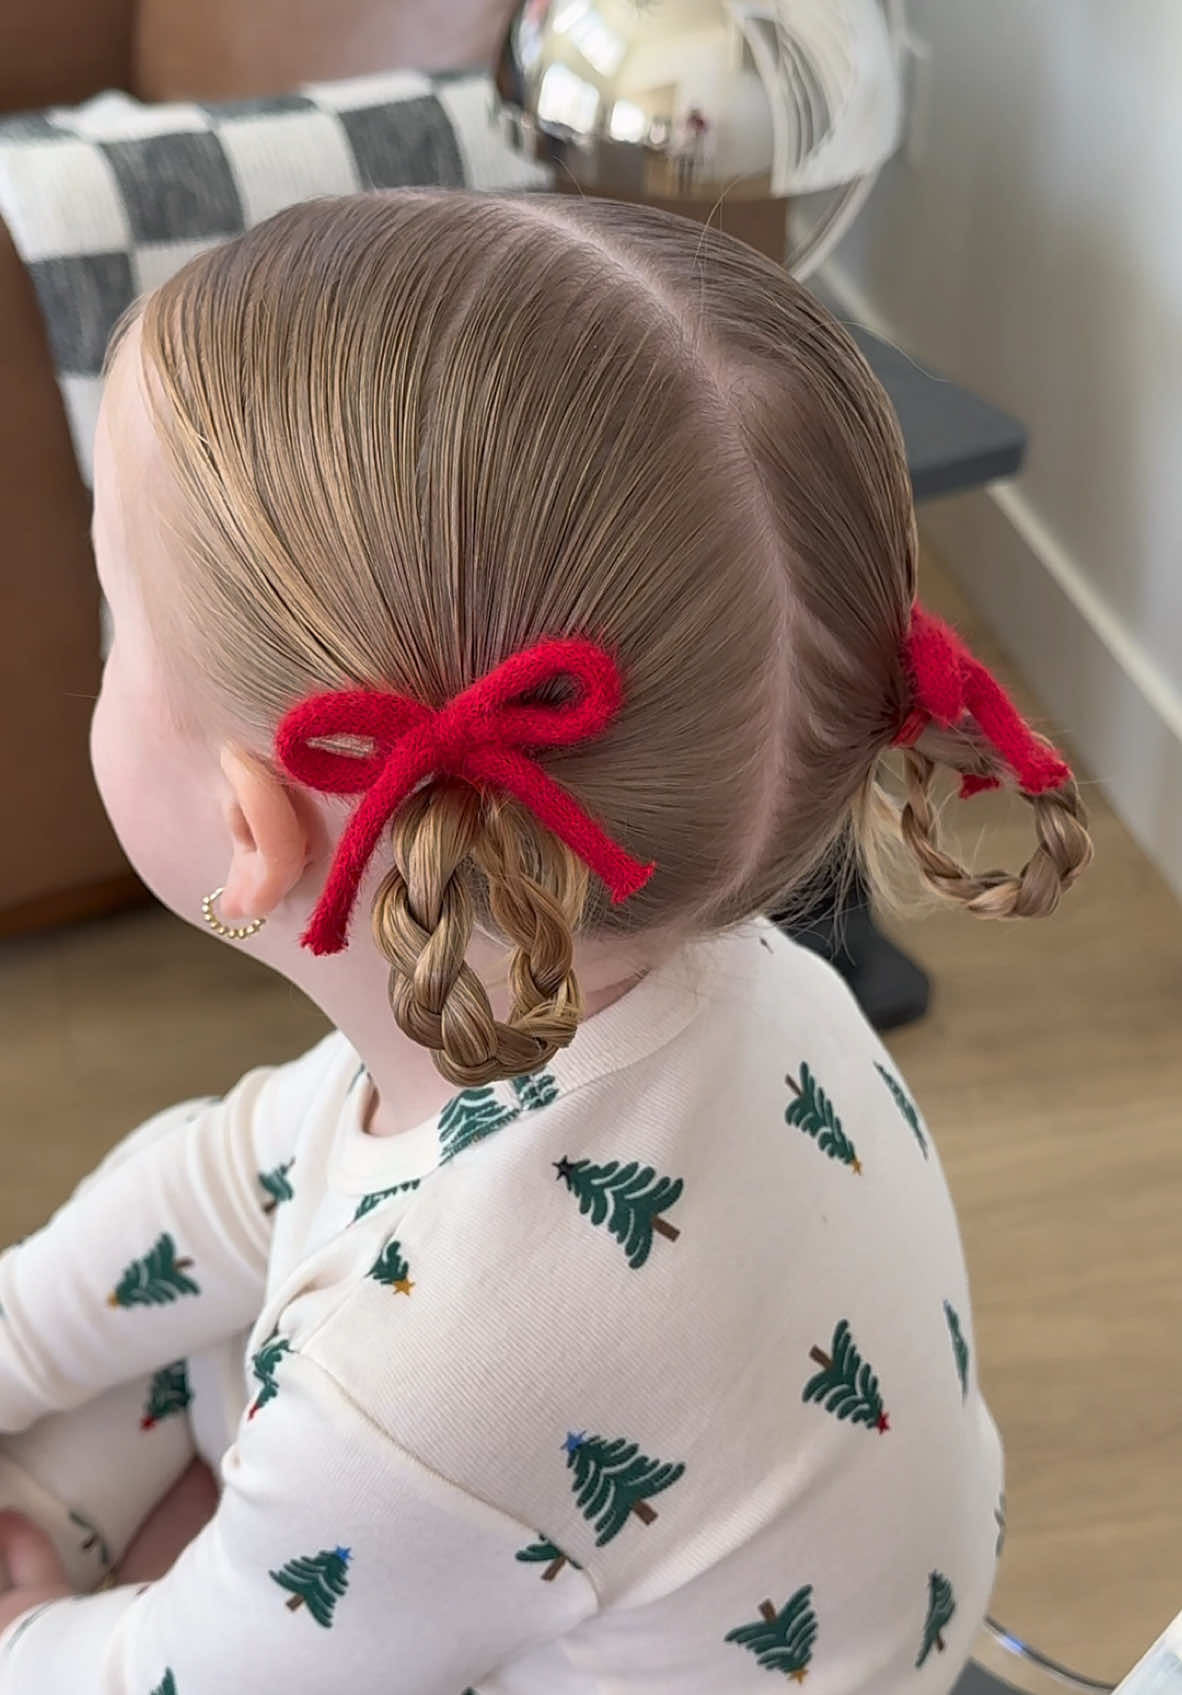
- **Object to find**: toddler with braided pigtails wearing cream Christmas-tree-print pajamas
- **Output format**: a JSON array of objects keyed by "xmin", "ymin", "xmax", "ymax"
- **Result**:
[{"xmin": 0, "ymin": 192, "xmax": 1089, "ymax": 1695}]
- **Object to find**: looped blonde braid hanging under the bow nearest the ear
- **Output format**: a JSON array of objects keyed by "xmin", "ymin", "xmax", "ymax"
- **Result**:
[{"xmin": 373, "ymin": 783, "xmax": 587, "ymax": 1086}]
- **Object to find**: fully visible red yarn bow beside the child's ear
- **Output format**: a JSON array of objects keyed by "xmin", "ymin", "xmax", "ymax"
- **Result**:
[{"xmin": 275, "ymin": 641, "xmax": 655, "ymax": 954}]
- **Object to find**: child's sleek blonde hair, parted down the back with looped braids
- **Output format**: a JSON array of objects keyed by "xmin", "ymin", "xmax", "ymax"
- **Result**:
[{"xmin": 124, "ymin": 192, "xmax": 1087, "ymax": 1085}]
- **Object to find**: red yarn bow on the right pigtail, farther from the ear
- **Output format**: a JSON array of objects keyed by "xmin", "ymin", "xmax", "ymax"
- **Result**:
[{"xmin": 894, "ymin": 603, "xmax": 1072, "ymax": 798}]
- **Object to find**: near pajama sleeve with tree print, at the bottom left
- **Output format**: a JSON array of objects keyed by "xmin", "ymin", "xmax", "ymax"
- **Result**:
[{"xmin": 0, "ymin": 1354, "xmax": 595, "ymax": 1695}]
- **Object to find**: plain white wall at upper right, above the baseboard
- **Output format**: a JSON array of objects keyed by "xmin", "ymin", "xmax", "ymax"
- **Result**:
[{"xmin": 829, "ymin": 0, "xmax": 1182, "ymax": 890}]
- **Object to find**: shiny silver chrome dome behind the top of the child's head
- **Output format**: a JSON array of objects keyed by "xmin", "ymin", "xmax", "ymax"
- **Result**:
[{"xmin": 497, "ymin": 0, "xmax": 899, "ymax": 275}]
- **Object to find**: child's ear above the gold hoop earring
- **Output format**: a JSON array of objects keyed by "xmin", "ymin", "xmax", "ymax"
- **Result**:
[{"xmin": 217, "ymin": 744, "xmax": 310, "ymax": 924}]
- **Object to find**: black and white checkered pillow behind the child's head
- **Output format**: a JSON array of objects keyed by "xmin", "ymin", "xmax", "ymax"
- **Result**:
[{"xmin": 0, "ymin": 71, "xmax": 548, "ymax": 485}]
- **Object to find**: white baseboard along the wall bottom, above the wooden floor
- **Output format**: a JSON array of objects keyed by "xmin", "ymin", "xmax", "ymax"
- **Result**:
[{"xmin": 819, "ymin": 263, "xmax": 1182, "ymax": 898}]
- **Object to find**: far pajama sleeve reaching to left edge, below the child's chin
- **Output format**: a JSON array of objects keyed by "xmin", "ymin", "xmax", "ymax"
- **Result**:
[{"xmin": 0, "ymin": 1049, "xmax": 317, "ymax": 1434}]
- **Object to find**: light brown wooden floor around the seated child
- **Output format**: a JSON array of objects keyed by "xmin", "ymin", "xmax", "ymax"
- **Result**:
[{"xmin": 0, "ymin": 566, "xmax": 1182, "ymax": 1678}]
